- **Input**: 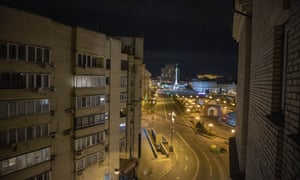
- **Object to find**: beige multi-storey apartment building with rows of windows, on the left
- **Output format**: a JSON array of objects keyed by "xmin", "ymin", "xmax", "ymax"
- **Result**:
[{"xmin": 0, "ymin": 6, "xmax": 144, "ymax": 180}]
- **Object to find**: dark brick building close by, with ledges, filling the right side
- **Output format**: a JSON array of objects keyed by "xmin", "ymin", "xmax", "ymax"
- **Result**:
[{"xmin": 230, "ymin": 0, "xmax": 300, "ymax": 179}]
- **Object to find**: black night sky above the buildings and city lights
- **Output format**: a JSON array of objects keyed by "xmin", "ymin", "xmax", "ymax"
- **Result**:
[{"xmin": 0, "ymin": 0, "xmax": 237, "ymax": 76}]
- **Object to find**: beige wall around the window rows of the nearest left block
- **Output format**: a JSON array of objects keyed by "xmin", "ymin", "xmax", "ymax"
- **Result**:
[{"xmin": 0, "ymin": 4, "xmax": 73, "ymax": 179}]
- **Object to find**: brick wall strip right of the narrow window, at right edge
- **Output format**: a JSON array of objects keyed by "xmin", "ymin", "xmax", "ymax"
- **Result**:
[{"xmin": 282, "ymin": 0, "xmax": 300, "ymax": 179}]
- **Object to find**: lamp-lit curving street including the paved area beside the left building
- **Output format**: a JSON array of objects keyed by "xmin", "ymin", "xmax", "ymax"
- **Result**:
[{"xmin": 140, "ymin": 96, "xmax": 230, "ymax": 180}]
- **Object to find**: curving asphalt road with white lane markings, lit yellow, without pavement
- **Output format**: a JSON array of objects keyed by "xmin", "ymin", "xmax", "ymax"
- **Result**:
[{"xmin": 150, "ymin": 96, "xmax": 230, "ymax": 180}]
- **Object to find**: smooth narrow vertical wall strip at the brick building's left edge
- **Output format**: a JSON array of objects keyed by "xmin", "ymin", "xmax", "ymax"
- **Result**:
[{"xmin": 235, "ymin": 3, "xmax": 251, "ymax": 171}]
